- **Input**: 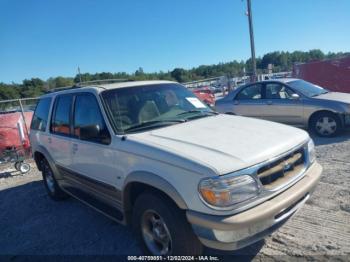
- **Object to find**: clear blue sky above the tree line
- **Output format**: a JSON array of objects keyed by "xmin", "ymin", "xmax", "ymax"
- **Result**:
[{"xmin": 0, "ymin": 0, "xmax": 350, "ymax": 82}]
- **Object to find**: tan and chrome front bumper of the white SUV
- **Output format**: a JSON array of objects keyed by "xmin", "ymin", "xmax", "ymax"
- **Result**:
[{"xmin": 186, "ymin": 163, "xmax": 322, "ymax": 250}]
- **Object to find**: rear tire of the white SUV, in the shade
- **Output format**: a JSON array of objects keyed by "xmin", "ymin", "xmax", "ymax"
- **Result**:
[{"xmin": 40, "ymin": 158, "xmax": 68, "ymax": 201}]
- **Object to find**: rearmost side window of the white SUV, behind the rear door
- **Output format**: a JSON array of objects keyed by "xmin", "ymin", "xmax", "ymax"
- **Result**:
[{"xmin": 30, "ymin": 97, "xmax": 52, "ymax": 131}]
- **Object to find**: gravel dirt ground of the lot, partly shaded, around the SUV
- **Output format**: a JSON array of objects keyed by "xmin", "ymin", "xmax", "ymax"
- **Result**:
[{"xmin": 0, "ymin": 132, "xmax": 350, "ymax": 261}]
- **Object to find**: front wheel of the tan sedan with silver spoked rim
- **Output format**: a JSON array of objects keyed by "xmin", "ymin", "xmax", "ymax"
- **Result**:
[{"xmin": 310, "ymin": 112, "xmax": 341, "ymax": 137}]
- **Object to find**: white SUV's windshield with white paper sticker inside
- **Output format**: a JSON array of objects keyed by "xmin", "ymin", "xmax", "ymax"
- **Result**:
[{"xmin": 102, "ymin": 84, "xmax": 214, "ymax": 133}]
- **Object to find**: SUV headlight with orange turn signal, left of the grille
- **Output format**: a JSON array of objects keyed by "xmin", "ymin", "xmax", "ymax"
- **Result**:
[{"xmin": 199, "ymin": 175, "xmax": 259, "ymax": 208}]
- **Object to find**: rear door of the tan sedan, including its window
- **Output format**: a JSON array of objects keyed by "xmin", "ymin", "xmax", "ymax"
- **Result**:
[{"xmin": 232, "ymin": 84, "xmax": 264, "ymax": 118}]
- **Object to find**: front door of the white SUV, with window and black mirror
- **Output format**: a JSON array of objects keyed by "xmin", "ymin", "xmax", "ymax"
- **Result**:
[{"xmin": 72, "ymin": 93, "xmax": 118, "ymax": 191}]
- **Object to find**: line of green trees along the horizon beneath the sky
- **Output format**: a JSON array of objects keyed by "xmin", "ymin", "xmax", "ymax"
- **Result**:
[{"xmin": 0, "ymin": 49, "xmax": 350, "ymax": 100}]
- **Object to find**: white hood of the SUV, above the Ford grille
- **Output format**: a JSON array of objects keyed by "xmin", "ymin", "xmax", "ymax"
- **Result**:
[{"xmin": 133, "ymin": 115, "xmax": 309, "ymax": 175}]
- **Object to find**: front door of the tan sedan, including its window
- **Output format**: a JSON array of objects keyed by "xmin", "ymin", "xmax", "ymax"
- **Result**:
[{"xmin": 261, "ymin": 82, "xmax": 303, "ymax": 126}]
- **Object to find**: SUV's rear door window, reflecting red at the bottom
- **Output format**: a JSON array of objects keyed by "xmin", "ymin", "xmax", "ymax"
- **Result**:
[{"xmin": 51, "ymin": 95, "xmax": 73, "ymax": 135}]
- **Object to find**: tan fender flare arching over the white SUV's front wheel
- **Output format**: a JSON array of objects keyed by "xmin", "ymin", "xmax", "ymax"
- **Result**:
[{"xmin": 123, "ymin": 171, "xmax": 188, "ymax": 209}]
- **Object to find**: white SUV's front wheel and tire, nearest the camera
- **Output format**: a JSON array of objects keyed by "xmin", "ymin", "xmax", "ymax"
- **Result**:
[{"xmin": 132, "ymin": 192, "xmax": 203, "ymax": 255}]
